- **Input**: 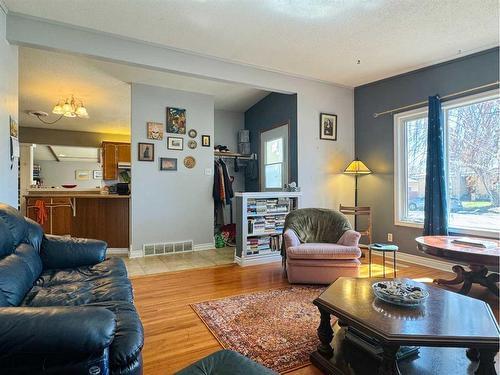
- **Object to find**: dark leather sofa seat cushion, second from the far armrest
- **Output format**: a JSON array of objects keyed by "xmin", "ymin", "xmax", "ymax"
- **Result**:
[{"xmin": 23, "ymin": 276, "xmax": 133, "ymax": 307}]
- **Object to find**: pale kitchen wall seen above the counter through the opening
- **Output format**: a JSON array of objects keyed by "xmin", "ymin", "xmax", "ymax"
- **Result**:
[{"xmin": 35, "ymin": 160, "xmax": 102, "ymax": 188}]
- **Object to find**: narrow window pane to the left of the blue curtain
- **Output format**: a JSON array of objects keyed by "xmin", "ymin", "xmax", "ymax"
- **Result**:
[{"xmin": 404, "ymin": 117, "xmax": 427, "ymax": 223}]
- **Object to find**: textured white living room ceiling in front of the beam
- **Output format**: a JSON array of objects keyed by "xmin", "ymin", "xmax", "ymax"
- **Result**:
[{"xmin": 4, "ymin": 0, "xmax": 499, "ymax": 86}]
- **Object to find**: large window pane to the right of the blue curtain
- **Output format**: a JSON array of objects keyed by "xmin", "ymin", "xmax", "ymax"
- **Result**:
[{"xmin": 446, "ymin": 99, "xmax": 500, "ymax": 231}]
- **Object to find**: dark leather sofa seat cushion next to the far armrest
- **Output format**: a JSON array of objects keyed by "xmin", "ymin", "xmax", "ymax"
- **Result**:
[{"xmin": 36, "ymin": 258, "xmax": 127, "ymax": 287}]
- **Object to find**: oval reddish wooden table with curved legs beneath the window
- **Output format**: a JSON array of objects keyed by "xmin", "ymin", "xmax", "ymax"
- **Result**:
[{"xmin": 416, "ymin": 236, "xmax": 500, "ymax": 296}]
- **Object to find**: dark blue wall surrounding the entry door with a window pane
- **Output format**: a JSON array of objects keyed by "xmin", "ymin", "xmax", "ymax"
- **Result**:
[{"xmin": 245, "ymin": 92, "xmax": 298, "ymax": 191}]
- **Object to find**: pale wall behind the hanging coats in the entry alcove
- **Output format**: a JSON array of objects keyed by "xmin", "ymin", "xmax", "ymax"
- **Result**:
[{"xmin": 213, "ymin": 110, "xmax": 245, "ymax": 220}]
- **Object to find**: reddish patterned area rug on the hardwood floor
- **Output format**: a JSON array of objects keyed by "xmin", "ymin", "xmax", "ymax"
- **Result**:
[{"xmin": 191, "ymin": 286, "xmax": 325, "ymax": 373}]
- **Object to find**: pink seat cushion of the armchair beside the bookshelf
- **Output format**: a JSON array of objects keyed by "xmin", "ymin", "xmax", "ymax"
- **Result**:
[{"xmin": 286, "ymin": 243, "xmax": 361, "ymax": 259}]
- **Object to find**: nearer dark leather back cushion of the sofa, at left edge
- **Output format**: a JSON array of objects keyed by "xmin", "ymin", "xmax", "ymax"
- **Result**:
[{"xmin": 0, "ymin": 244, "xmax": 42, "ymax": 306}]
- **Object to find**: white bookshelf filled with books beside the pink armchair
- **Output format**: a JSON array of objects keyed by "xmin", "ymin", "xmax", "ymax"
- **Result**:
[{"xmin": 235, "ymin": 192, "xmax": 301, "ymax": 266}]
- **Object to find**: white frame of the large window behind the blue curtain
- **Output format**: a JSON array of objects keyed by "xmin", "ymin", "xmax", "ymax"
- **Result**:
[{"xmin": 393, "ymin": 89, "xmax": 500, "ymax": 237}]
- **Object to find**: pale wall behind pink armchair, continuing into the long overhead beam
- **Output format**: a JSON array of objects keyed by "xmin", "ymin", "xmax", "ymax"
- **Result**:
[{"xmin": 7, "ymin": 15, "xmax": 354, "ymax": 250}]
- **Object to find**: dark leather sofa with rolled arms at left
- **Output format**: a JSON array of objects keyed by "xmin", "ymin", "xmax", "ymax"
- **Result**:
[{"xmin": 0, "ymin": 204, "xmax": 144, "ymax": 375}]
